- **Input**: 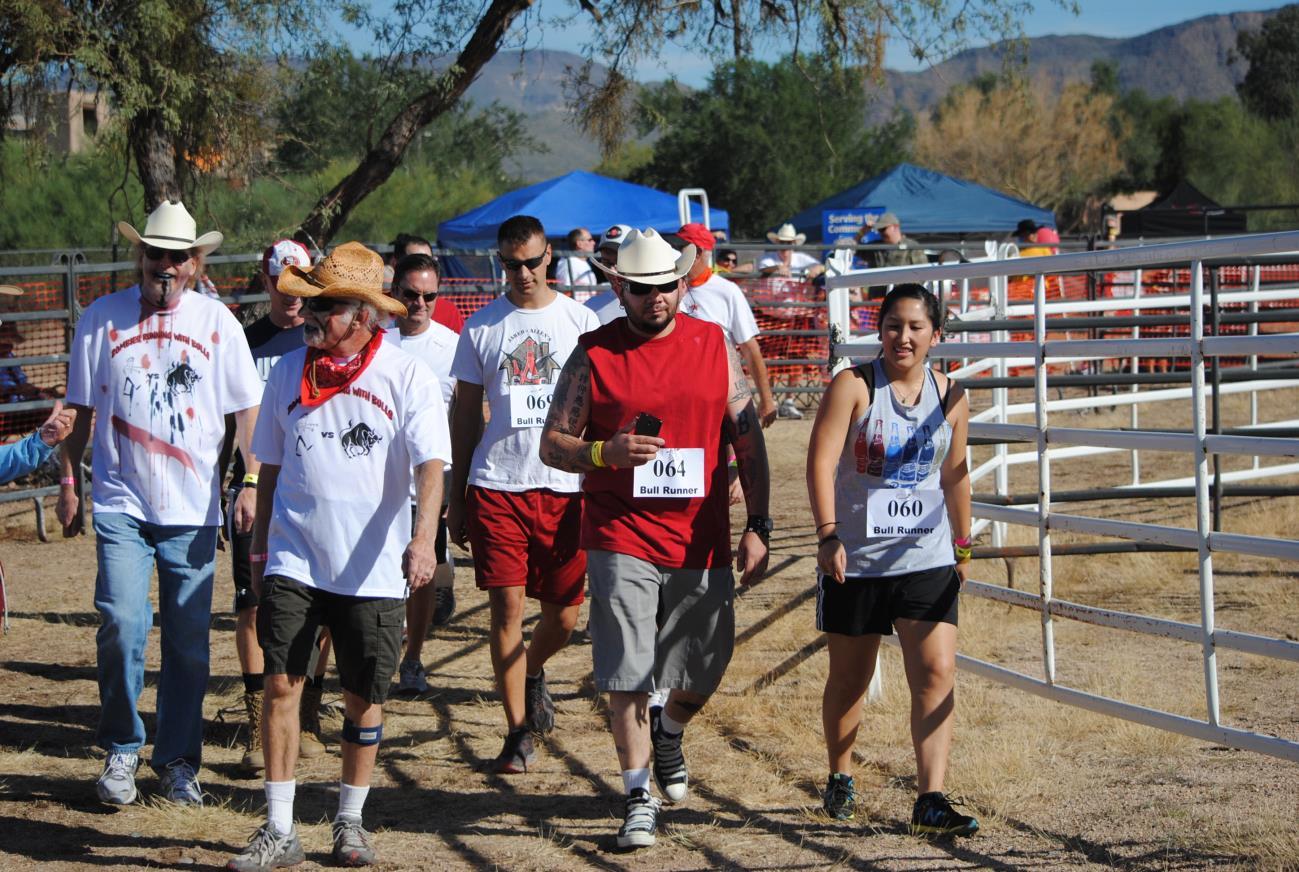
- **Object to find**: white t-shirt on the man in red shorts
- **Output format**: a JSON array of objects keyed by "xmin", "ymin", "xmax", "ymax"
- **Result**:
[{"xmin": 451, "ymin": 294, "xmax": 600, "ymax": 494}]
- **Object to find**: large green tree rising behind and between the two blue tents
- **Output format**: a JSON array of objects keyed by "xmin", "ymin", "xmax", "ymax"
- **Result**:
[{"xmin": 631, "ymin": 57, "xmax": 912, "ymax": 237}]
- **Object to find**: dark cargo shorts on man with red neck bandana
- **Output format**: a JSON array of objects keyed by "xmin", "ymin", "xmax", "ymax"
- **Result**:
[{"xmin": 257, "ymin": 576, "xmax": 405, "ymax": 703}]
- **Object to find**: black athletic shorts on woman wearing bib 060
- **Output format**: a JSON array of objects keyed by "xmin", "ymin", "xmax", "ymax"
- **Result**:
[{"xmin": 816, "ymin": 567, "xmax": 961, "ymax": 635}]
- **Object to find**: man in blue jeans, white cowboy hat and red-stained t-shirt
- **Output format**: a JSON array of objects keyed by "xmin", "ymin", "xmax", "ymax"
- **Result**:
[{"xmin": 58, "ymin": 201, "xmax": 261, "ymax": 804}]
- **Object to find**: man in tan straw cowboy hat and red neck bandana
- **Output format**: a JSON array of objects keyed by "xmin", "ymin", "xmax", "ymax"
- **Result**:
[{"xmin": 226, "ymin": 242, "xmax": 451, "ymax": 869}]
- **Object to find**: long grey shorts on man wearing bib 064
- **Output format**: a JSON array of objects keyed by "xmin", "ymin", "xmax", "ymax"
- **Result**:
[{"xmin": 586, "ymin": 551, "xmax": 735, "ymax": 695}]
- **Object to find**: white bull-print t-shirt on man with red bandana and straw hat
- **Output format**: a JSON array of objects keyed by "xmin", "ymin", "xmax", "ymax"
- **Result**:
[{"xmin": 252, "ymin": 342, "xmax": 451, "ymax": 599}]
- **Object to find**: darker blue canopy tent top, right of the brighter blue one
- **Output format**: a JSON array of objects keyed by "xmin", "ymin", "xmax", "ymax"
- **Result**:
[{"xmin": 773, "ymin": 164, "xmax": 1055, "ymax": 242}]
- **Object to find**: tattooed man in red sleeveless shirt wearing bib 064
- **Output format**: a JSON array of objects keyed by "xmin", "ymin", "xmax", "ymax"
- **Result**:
[{"xmin": 542, "ymin": 230, "xmax": 772, "ymax": 847}]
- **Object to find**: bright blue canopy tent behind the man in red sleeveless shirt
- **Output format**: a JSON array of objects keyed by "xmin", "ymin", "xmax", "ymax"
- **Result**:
[{"xmin": 438, "ymin": 170, "xmax": 730, "ymax": 248}]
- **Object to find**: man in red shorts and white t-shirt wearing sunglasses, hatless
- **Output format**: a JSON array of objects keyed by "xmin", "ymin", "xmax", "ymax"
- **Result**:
[{"xmin": 447, "ymin": 214, "xmax": 600, "ymax": 773}]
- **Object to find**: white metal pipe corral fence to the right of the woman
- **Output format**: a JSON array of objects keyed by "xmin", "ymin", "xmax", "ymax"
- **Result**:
[{"xmin": 826, "ymin": 233, "xmax": 1299, "ymax": 762}]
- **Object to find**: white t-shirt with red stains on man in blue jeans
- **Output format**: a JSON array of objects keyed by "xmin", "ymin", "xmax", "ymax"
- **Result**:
[{"xmin": 68, "ymin": 286, "xmax": 261, "ymax": 526}]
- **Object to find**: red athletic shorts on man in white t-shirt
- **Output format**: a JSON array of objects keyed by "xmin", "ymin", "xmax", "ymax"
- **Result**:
[{"xmin": 466, "ymin": 485, "xmax": 586, "ymax": 606}]
